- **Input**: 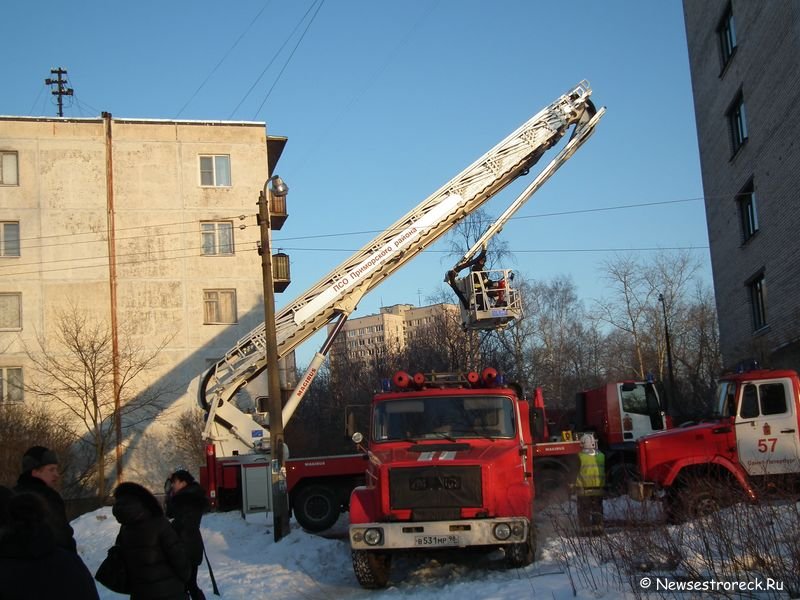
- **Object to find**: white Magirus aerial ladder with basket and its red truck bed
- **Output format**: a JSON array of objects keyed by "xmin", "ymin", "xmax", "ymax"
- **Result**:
[{"xmin": 198, "ymin": 81, "xmax": 605, "ymax": 529}]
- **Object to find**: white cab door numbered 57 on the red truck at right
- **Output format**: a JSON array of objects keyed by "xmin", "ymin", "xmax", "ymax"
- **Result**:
[{"xmin": 735, "ymin": 378, "xmax": 800, "ymax": 476}]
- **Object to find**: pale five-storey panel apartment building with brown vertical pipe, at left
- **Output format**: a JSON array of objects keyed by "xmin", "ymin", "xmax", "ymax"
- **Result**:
[{"xmin": 0, "ymin": 113, "xmax": 286, "ymax": 480}]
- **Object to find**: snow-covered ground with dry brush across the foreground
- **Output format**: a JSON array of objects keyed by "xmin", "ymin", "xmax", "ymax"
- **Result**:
[{"xmin": 72, "ymin": 497, "xmax": 800, "ymax": 600}]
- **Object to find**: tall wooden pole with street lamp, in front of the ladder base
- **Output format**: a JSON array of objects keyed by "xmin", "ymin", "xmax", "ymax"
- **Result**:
[{"xmin": 258, "ymin": 175, "xmax": 290, "ymax": 542}]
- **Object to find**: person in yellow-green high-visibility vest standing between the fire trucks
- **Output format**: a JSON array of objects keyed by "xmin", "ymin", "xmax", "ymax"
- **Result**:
[{"xmin": 575, "ymin": 433, "xmax": 606, "ymax": 535}]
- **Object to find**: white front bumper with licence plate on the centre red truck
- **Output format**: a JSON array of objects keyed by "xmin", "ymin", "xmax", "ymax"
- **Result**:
[{"xmin": 350, "ymin": 517, "xmax": 530, "ymax": 550}]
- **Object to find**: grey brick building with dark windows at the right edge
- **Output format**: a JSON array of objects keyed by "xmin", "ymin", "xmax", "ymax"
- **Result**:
[{"xmin": 683, "ymin": 0, "xmax": 800, "ymax": 369}]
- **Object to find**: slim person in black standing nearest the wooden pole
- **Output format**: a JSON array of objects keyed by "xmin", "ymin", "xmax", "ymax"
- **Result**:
[{"xmin": 167, "ymin": 469, "xmax": 208, "ymax": 600}]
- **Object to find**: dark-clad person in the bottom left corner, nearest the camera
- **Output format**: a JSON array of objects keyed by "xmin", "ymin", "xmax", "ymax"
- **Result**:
[{"xmin": 0, "ymin": 488, "xmax": 98, "ymax": 600}]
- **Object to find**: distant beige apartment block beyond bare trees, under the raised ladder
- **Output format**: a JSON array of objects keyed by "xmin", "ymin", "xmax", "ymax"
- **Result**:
[{"xmin": 328, "ymin": 304, "xmax": 460, "ymax": 363}]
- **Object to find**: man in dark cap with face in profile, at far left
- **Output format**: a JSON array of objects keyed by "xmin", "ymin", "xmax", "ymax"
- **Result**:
[{"xmin": 14, "ymin": 446, "xmax": 78, "ymax": 554}]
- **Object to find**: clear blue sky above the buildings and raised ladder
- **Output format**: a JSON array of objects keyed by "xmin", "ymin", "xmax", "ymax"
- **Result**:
[{"xmin": 0, "ymin": 0, "xmax": 710, "ymax": 360}]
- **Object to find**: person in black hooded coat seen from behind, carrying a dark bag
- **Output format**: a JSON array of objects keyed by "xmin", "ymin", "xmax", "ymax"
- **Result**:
[{"xmin": 112, "ymin": 481, "xmax": 191, "ymax": 600}]
